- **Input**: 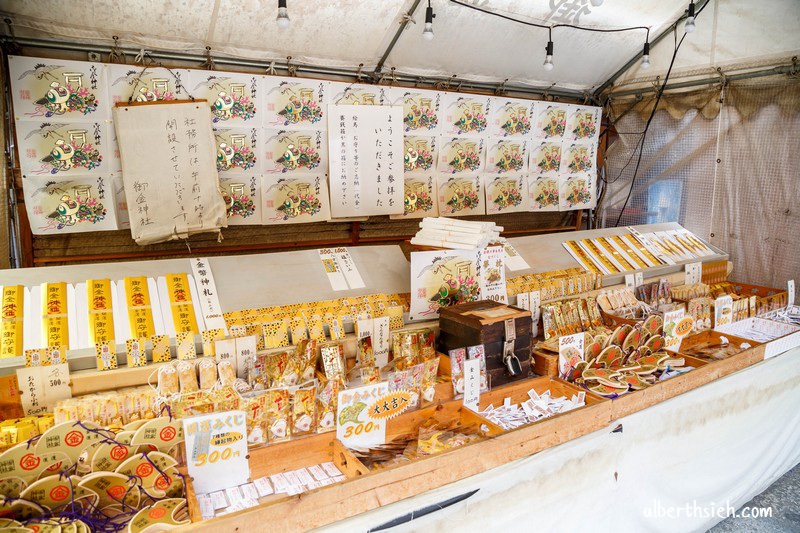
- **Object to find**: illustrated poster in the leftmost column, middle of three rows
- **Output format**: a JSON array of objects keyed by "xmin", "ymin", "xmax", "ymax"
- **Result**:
[{"xmin": 16, "ymin": 121, "xmax": 111, "ymax": 177}]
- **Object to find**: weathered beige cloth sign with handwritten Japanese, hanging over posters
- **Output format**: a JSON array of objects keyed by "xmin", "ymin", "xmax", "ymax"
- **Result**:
[{"xmin": 114, "ymin": 100, "xmax": 228, "ymax": 244}]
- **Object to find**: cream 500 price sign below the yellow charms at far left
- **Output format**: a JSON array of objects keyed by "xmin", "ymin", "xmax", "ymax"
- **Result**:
[{"xmin": 17, "ymin": 363, "xmax": 72, "ymax": 416}]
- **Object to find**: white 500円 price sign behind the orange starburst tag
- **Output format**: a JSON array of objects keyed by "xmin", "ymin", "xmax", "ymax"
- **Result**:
[{"xmin": 336, "ymin": 381, "xmax": 389, "ymax": 448}]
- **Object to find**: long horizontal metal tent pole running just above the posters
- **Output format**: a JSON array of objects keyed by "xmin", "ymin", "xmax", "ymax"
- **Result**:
[{"xmin": 0, "ymin": 37, "xmax": 585, "ymax": 102}]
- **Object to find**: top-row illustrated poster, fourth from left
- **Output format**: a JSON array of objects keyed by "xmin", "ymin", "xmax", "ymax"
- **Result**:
[{"xmin": 264, "ymin": 77, "xmax": 328, "ymax": 130}]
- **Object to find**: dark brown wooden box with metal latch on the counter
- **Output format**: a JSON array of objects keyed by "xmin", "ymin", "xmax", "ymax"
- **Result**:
[{"xmin": 439, "ymin": 300, "xmax": 533, "ymax": 387}]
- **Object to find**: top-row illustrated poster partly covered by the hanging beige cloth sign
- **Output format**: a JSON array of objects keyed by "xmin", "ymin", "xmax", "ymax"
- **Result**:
[{"xmin": 106, "ymin": 64, "xmax": 189, "ymax": 105}]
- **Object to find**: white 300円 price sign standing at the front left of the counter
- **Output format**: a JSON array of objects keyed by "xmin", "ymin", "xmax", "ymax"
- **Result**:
[{"xmin": 183, "ymin": 411, "xmax": 250, "ymax": 493}]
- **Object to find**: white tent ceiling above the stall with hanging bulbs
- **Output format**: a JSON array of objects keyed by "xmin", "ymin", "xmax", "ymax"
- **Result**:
[{"xmin": 0, "ymin": 0, "xmax": 800, "ymax": 91}]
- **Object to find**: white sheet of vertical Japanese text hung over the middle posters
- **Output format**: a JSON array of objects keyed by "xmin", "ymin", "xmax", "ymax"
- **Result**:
[{"xmin": 328, "ymin": 105, "xmax": 404, "ymax": 218}]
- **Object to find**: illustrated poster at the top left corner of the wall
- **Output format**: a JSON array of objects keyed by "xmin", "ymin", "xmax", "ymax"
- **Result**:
[{"xmin": 8, "ymin": 56, "xmax": 111, "ymax": 122}]
